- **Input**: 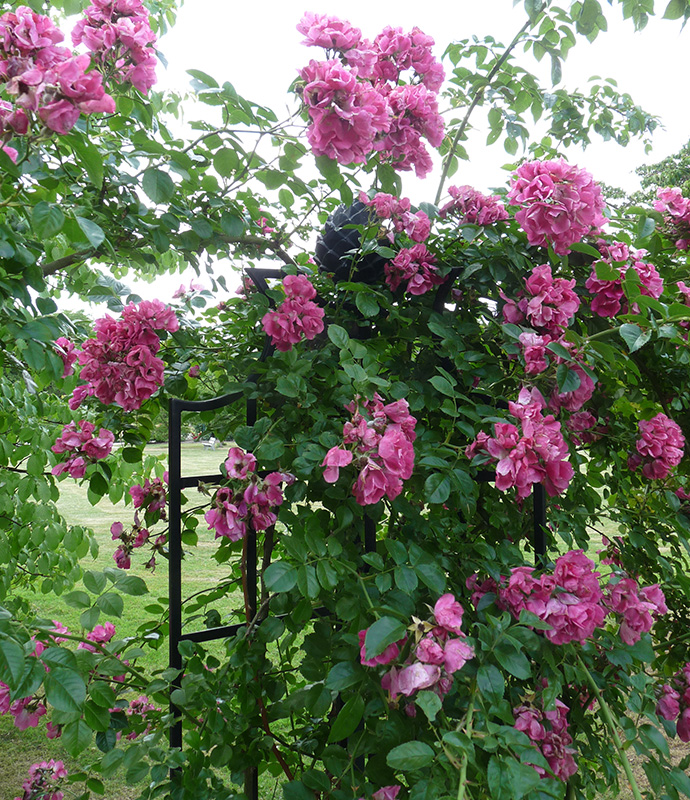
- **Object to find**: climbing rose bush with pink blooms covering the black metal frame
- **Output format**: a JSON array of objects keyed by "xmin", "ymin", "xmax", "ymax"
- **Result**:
[{"xmin": 0, "ymin": 0, "xmax": 690, "ymax": 800}]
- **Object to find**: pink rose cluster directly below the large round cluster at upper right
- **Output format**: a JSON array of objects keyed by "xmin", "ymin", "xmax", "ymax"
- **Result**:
[{"xmin": 500, "ymin": 264, "xmax": 580, "ymax": 341}]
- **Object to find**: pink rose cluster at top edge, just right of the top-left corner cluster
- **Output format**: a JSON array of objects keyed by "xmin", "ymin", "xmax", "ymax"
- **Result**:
[{"xmin": 72, "ymin": 0, "xmax": 157, "ymax": 94}]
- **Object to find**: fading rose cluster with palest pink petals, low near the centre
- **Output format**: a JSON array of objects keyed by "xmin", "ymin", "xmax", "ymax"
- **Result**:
[{"xmin": 359, "ymin": 593, "xmax": 474, "ymax": 715}]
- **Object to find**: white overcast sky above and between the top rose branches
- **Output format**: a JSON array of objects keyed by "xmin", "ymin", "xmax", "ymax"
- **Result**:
[{"xmin": 160, "ymin": 0, "xmax": 690, "ymax": 199}]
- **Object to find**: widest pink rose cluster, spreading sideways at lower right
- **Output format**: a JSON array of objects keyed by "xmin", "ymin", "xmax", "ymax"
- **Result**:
[{"xmin": 467, "ymin": 550, "xmax": 668, "ymax": 645}]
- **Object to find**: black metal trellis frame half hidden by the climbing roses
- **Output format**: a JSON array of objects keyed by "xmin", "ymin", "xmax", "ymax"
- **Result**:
[{"xmin": 168, "ymin": 269, "xmax": 546, "ymax": 800}]
